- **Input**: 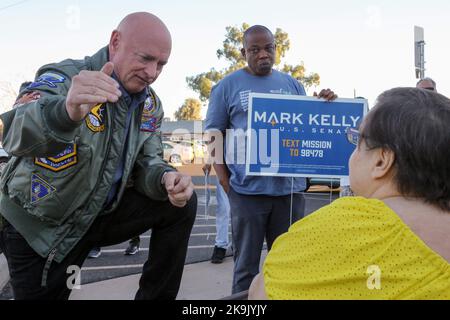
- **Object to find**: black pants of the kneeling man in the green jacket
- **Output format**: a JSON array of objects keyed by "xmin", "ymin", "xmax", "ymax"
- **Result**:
[{"xmin": 0, "ymin": 189, "xmax": 197, "ymax": 300}]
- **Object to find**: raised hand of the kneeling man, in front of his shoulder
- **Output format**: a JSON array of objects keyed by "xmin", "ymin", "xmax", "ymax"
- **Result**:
[{"xmin": 66, "ymin": 62, "xmax": 122, "ymax": 122}]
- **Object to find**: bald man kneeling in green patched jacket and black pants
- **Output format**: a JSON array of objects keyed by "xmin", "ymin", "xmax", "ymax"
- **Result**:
[{"xmin": 0, "ymin": 12, "xmax": 197, "ymax": 299}]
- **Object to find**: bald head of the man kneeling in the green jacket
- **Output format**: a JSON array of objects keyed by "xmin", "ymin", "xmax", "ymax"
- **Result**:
[{"xmin": 109, "ymin": 12, "xmax": 172, "ymax": 93}]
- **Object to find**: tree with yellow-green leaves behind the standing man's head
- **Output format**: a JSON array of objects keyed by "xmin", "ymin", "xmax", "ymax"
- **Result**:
[{"xmin": 186, "ymin": 22, "xmax": 320, "ymax": 102}]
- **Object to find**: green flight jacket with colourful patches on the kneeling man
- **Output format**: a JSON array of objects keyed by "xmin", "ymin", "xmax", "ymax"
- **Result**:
[{"xmin": 0, "ymin": 47, "xmax": 175, "ymax": 262}]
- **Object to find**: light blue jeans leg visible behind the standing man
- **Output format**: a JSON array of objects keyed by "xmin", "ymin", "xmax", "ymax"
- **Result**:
[{"xmin": 215, "ymin": 178, "xmax": 230, "ymax": 249}]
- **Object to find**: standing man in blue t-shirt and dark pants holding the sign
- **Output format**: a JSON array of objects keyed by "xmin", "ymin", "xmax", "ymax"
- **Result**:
[{"xmin": 206, "ymin": 25, "xmax": 337, "ymax": 293}]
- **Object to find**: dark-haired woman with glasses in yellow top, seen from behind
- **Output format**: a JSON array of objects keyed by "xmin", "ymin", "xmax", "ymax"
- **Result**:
[{"xmin": 249, "ymin": 88, "xmax": 450, "ymax": 299}]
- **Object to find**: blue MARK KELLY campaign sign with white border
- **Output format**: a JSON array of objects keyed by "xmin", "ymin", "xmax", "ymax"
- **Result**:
[{"xmin": 246, "ymin": 93, "xmax": 368, "ymax": 178}]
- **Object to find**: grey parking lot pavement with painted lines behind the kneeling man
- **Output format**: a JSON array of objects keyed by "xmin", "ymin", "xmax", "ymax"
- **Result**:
[{"xmin": 0, "ymin": 170, "xmax": 336, "ymax": 299}]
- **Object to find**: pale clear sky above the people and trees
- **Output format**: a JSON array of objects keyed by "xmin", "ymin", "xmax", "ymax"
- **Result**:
[{"xmin": 0, "ymin": 0, "xmax": 450, "ymax": 117}]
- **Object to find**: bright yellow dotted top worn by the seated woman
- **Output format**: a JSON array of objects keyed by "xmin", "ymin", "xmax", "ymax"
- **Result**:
[{"xmin": 263, "ymin": 197, "xmax": 450, "ymax": 299}]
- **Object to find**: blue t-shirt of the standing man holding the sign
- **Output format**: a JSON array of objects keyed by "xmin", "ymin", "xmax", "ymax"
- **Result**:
[{"xmin": 205, "ymin": 69, "xmax": 306, "ymax": 196}]
